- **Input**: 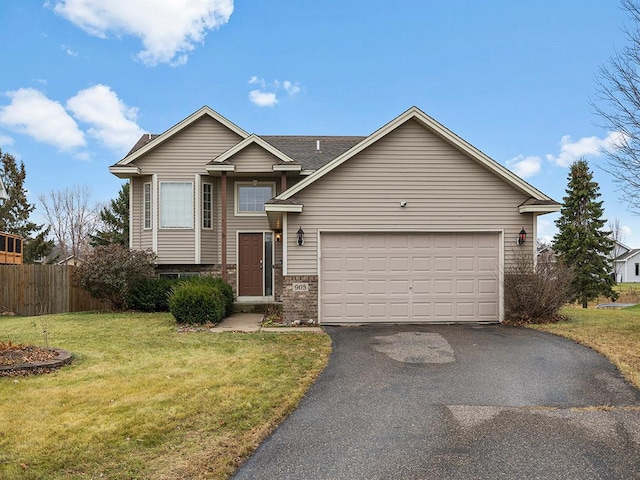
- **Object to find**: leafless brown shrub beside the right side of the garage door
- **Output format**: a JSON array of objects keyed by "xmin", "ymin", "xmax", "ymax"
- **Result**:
[{"xmin": 504, "ymin": 252, "xmax": 573, "ymax": 324}]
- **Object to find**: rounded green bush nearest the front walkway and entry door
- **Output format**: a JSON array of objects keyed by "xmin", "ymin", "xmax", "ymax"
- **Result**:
[{"xmin": 169, "ymin": 277, "xmax": 226, "ymax": 324}]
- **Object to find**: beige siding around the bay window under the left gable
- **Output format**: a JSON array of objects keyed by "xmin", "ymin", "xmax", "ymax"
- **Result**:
[{"xmin": 134, "ymin": 116, "xmax": 242, "ymax": 264}]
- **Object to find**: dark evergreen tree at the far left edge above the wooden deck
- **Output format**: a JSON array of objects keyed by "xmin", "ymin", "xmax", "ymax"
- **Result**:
[{"xmin": 0, "ymin": 151, "xmax": 42, "ymax": 238}]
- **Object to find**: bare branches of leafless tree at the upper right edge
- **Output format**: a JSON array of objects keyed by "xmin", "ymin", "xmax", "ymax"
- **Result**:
[{"xmin": 592, "ymin": 0, "xmax": 640, "ymax": 212}]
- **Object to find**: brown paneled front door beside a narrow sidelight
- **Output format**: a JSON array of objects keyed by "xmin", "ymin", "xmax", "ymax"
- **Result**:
[{"xmin": 238, "ymin": 233, "xmax": 264, "ymax": 297}]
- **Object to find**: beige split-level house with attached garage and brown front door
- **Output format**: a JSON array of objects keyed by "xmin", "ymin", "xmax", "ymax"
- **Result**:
[{"xmin": 110, "ymin": 107, "xmax": 560, "ymax": 324}]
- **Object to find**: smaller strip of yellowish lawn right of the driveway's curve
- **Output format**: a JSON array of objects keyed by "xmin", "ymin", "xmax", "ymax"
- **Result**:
[{"xmin": 531, "ymin": 305, "xmax": 640, "ymax": 388}]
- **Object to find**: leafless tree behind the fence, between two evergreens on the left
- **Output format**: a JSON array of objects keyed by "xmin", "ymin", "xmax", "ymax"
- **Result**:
[{"xmin": 38, "ymin": 186, "xmax": 101, "ymax": 265}]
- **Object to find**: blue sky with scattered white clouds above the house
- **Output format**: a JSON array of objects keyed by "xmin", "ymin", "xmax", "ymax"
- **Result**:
[{"xmin": 0, "ymin": 0, "xmax": 640, "ymax": 247}]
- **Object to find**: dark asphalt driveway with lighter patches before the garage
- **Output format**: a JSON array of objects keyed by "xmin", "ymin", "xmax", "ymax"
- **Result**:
[{"xmin": 234, "ymin": 325, "xmax": 640, "ymax": 479}]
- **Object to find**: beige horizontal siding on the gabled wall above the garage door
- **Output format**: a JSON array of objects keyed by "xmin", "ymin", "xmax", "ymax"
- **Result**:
[{"xmin": 287, "ymin": 121, "xmax": 535, "ymax": 275}]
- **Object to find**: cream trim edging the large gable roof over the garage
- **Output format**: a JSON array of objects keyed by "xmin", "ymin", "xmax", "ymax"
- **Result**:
[{"xmin": 276, "ymin": 107, "xmax": 560, "ymax": 213}]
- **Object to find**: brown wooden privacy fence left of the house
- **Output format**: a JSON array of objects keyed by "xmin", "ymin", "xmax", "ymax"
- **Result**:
[{"xmin": 0, "ymin": 265, "xmax": 110, "ymax": 316}]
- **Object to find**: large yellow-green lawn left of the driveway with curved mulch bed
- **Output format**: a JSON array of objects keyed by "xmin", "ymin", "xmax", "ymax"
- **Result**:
[{"xmin": 0, "ymin": 313, "xmax": 331, "ymax": 479}]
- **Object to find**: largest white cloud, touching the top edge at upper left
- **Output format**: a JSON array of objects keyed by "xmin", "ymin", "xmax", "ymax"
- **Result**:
[{"xmin": 52, "ymin": 0, "xmax": 233, "ymax": 66}]
